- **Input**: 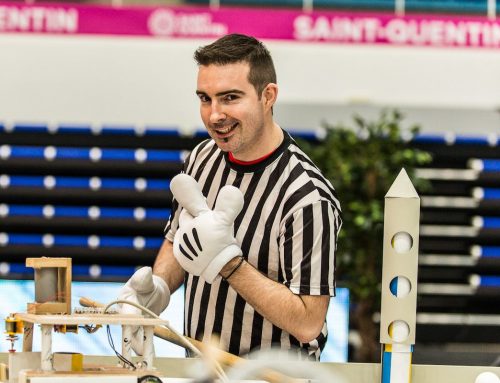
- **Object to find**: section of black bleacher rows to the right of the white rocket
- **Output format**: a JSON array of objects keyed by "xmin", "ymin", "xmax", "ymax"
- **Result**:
[{"xmin": 412, "ymin": 134, "xmax": 500, "ymax": 363}]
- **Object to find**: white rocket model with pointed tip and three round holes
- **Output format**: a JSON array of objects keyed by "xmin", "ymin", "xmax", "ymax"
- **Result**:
[{"xmin": 380, "ymin": 169, "xmax": 420, "ymax": 383}]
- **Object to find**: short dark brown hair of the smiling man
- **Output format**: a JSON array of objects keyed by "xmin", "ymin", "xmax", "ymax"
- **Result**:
[{"xmin": 194, "ymin": 34, "xmax": 277, "ymax": 99}]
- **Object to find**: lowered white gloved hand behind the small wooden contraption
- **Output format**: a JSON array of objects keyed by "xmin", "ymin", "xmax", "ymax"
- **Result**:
[{"xmin": 118, "ymin": 267, "xmax": 170, "ymax": 355}]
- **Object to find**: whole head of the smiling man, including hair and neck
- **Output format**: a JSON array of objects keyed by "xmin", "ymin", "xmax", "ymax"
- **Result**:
[{"xmin": 195, "ymin": 35, "xmax": 283, "ymax": 161}]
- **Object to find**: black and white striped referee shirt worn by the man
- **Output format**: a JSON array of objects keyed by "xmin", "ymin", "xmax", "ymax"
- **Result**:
[{"xmin": 165, "ymin": 133, "xmax": 341, "ymax": 359}]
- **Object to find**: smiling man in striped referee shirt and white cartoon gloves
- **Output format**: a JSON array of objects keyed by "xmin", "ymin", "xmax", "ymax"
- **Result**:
[{"xmin": 121, "ymin": 34, "xmax": 341, "ymax": 360}]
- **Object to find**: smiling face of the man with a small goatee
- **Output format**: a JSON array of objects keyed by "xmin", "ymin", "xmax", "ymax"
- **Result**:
[{"xmin": 196, "ymin": 62, "xmax": 266, "ymax": 161}]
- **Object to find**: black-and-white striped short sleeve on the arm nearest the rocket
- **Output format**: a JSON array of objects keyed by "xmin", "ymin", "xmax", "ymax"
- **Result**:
[{"xmin": 280, "ymin": 200, "xmax": 339, "ymax": 296}]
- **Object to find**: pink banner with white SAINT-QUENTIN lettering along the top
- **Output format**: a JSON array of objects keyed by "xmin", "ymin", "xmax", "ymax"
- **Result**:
[{"xmin": 0, "ymin": 3, "xmax": 500, "ymax": 48}]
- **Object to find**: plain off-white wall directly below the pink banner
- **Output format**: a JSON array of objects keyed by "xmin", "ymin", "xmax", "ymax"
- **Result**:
[{"xmin": 0, "ymin": 3, "xmax": 500, "ymax": 134}]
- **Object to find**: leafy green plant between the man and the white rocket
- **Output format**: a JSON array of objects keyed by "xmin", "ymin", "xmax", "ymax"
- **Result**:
[{"xmin": 301, "ymin": 111, "xmax": 431, "ymax": 362}]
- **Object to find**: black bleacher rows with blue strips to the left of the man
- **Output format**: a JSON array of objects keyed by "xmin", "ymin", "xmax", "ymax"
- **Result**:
[{"xmin": 0, "ymin": 124, "xmax": 203, "ymax": 281}]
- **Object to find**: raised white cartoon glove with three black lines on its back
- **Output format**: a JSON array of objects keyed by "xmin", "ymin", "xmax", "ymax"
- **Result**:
[{"xmin": 170, "ymin": 174, "xmax": 243, "ymax": 283}]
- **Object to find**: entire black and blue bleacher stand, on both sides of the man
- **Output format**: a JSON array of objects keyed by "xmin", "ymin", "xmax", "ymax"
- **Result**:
[{"xmin": 0, "ymin": 124, "xmax": 500, "ymax": 362}]
